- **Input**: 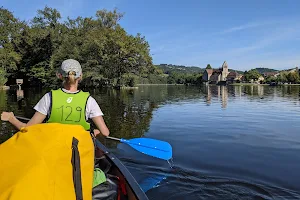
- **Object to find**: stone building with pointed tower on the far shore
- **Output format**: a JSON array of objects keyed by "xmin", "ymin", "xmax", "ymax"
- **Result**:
[{"xmin": 202, "ymin": 61, "xmax": 241, "ymax": 84}]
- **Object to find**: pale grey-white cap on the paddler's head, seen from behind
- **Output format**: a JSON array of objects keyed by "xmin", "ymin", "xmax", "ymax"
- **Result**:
[{"xmin": 58, "ymin": 59, "xmax": 82, "ymax": 78}]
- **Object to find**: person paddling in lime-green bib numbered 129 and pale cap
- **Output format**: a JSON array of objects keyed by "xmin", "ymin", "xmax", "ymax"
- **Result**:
[{"xmin": 1, "ymin": 59, "xmax": 109, "ymax": 136}]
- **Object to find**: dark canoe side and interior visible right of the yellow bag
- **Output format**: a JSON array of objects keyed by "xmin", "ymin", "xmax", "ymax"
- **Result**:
[{"xmin": 93, "ymin": 140, "xmax": 148, "ymax": 200}]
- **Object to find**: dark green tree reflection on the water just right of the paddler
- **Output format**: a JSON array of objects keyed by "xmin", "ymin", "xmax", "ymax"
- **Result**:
[{"xmin": 91, "ymin": 89, "xmax": 156, "ymax": 145}]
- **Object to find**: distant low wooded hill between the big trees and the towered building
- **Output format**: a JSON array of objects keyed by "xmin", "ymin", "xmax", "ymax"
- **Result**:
[{"xmin": 156, "ymin": 64, "xmax": 205, "ymax": 74}]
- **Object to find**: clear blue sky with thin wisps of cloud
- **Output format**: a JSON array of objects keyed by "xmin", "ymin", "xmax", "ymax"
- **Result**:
[{"xmin": 0, "ymin": 0, "xmax": 300, "ymax": 70}]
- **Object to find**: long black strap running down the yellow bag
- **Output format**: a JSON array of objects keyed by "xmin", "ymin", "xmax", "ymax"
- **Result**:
[{"xmin": 72, "ymin": 137, "xmax": 83, "ymax": 200}]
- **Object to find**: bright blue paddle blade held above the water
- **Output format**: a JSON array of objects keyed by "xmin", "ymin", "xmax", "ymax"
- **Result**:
[{"xmin": 120, "ymin": 138, "xmax": 172, "ymax": 160}]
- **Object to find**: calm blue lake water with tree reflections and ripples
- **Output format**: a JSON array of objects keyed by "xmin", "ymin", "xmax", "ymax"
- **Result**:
[{"xmin": 0, "ymin": 86, "xmax": 300, "ymax": 200}]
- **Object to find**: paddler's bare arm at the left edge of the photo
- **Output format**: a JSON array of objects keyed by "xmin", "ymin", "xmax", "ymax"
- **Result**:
[{"xmin": 1, "ymin": 112, "xmax": 46, "ymax": 130}]
